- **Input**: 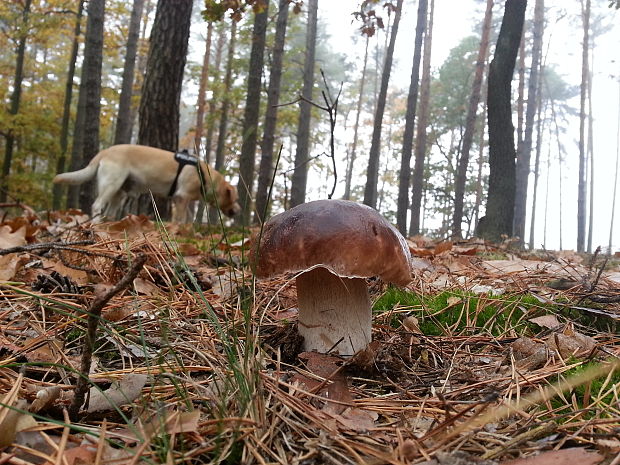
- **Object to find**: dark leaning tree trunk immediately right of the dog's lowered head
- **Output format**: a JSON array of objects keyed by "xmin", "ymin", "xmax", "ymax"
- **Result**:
[{"xmin": 237, "ymin": 2, "xmax": 269, "ymax": 226}]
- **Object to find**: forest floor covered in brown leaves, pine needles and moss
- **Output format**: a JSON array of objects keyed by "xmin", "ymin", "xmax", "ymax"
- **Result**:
[{"xmin": 0, "ymin": 211, "xmax": 620, "ymax": 465}]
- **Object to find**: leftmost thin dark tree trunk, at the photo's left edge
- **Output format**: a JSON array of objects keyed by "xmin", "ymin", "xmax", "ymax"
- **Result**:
[{"xmin": 0, "ymin": 0, "xmax": 32, "ymax": 202}]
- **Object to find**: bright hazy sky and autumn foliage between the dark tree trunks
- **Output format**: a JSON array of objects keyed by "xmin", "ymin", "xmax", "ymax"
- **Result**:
[{"xmin": 0, "ymin": 0, "xmax": 620, "ymax": 250}]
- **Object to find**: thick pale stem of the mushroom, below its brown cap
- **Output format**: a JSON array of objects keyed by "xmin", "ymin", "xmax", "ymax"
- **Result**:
[{"xmin": 297, "ymin": 267, "xmax": 372, "ymax": 355}]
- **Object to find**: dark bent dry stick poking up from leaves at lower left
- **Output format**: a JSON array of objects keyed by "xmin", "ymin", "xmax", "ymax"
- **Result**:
[{"xmin": 69, "ymin": 254, "xmax": 146, "ymax": 421}]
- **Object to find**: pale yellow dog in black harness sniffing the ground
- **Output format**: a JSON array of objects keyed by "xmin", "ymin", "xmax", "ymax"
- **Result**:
[{"xmin": 53, "ymin": 144, "xmax": 241, "ymax": 223}]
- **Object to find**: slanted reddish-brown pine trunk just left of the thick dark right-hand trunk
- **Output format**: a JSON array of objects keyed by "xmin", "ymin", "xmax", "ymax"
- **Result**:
[{"xmin": 452, "ymin": 0, "xmax": 493, "ymax": 239}]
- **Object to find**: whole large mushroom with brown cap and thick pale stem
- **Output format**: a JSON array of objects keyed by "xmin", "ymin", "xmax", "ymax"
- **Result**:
[{"xmin": 252, "ymin": 200, "xmax": 411, "ymax": 355}]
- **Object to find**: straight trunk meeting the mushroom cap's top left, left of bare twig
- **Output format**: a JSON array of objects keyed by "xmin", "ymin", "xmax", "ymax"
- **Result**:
[{"xmin": 291, "ymin": 0, "xmax": 319, "ymax": 207}]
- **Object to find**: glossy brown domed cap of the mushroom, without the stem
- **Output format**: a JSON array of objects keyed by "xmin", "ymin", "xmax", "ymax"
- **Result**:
[{"xmin": 252, "ymin": 200, "xmax": 411, "ymax": 286}]
